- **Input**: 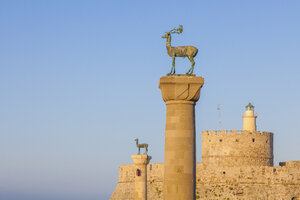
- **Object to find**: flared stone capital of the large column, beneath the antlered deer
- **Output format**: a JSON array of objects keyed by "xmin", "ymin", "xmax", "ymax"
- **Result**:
[{"xmin": 158, "ymin": 75, "xmax": 204, "ymax": 102}]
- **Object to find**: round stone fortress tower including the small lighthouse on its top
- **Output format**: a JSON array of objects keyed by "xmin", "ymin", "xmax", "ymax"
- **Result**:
[{"xmin": 202, "ymin": 104, "xmax": 273, "ymax": 166}]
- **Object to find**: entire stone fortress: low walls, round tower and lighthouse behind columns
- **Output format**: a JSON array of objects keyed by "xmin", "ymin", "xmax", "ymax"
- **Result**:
[{"xmin": 111, "ymin": 103, "xmax": 300, "ymax": 200}]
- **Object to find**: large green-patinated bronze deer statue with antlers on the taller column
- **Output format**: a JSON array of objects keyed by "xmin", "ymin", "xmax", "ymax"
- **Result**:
[{"xmin": 162, "ymin": 25, "xmax": 198, "ymax": 75}]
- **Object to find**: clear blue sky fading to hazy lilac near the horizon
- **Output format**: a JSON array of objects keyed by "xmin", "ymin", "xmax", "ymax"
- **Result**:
[{"xmin": 0, "ymin": 0, "xmax": 300, "ymax": 200}]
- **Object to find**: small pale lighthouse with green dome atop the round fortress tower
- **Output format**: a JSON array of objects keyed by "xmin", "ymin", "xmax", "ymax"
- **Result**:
[{"xmin": 242, "ymin": 103, "xmax": 257, "ymax": 131}]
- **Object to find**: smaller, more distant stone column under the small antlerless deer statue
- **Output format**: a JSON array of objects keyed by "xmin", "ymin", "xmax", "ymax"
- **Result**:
[{"xmin": 131, "ymin": 154, "xmax": 151, "ymax": 200}]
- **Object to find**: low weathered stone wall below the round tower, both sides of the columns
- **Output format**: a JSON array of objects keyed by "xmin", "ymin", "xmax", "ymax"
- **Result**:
[{"xmin": 110, "ymin": 161, "xmax": 300, "ymax": 200}]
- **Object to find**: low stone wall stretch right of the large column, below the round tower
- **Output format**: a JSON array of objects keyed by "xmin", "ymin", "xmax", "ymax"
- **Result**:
[{"xmin": 196, "ymin": 161, "xmax": 300, "ymax": 200}]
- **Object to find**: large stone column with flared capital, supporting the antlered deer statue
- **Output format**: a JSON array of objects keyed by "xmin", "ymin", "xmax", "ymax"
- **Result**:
[{"xmin": 159, "ymin": 75, "xmax": 204, "ymax": 200}]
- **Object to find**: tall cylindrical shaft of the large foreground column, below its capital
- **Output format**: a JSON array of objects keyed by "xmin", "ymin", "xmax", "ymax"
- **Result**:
[{"xmin": 164, "ymin": 100, "xmax": 196, "ymax": 200}]
